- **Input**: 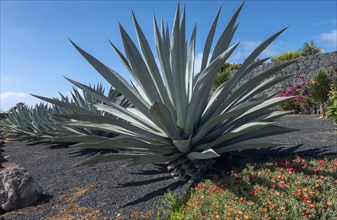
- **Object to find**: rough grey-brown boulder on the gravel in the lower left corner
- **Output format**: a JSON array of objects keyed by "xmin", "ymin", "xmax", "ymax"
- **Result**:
[{"xmin": 0, "ymin": 164, "xmax": 42, "ymax": 211}]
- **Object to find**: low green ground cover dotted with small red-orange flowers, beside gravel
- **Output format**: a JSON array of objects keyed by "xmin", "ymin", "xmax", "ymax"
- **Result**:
[{"xmin": 158, "ymin": 156, "xmax": 337, "ymax": 219}]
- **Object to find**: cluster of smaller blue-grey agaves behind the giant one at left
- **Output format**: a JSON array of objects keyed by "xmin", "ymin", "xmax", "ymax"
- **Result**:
[{"xmin": 1, "ymin": 84, "xmax": 130, "ymax": 142}]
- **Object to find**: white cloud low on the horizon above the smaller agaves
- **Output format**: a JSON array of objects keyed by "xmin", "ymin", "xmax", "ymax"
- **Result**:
[{"xmin": 0, "ymin": 92, "xmax": 40, "ymax": 111}]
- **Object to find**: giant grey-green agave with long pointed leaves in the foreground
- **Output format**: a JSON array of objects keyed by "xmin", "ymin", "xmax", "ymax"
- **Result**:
[{"xmin": 36, "ymin": 0, "xmax": 294, "ymax": 181}]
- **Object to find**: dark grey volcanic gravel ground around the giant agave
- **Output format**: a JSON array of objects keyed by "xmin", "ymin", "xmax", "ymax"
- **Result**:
[{"xmin": 0, "ymin": 116, "xmax": 337, "ymax": 220}]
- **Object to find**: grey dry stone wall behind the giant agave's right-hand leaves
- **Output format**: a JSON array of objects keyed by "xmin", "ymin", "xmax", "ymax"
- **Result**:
[{"xmin": 232, "ymin": 51, "xmax": 337, "ymax": 93}]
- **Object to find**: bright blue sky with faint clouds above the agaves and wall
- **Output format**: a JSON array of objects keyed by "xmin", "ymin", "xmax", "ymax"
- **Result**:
[{"xmin": 0, "ymin": 0, "xmax": 337, "ymax": 110}]
